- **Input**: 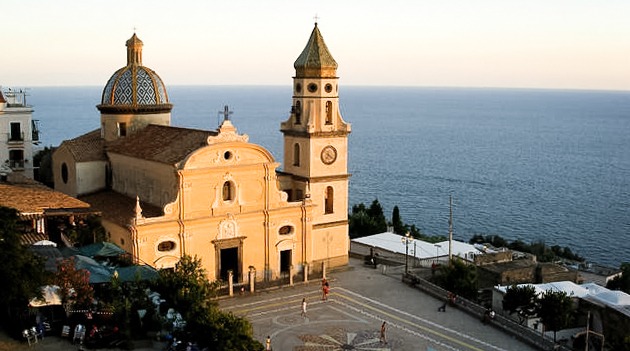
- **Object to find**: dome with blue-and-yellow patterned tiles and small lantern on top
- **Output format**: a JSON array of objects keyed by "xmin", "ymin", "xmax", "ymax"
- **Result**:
[{"xmin": 97, "ymin": 33, "xmax": 173, "ymax": 113}]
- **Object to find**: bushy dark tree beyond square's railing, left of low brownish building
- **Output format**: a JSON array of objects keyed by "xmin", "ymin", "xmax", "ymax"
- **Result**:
[{"xmin": 432, "ymin": 258, "xmax": 478, "ymax": 300}]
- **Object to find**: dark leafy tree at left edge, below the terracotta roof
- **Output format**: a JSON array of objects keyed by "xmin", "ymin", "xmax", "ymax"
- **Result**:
[{"xmin": 0, "ymin": 206, "xmax": 46, "ymax": 332}]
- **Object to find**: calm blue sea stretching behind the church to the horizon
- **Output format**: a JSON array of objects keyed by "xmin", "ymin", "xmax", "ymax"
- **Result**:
[{"xmin": 28, "ymin": 86, "xmax": 630, "ymax": 267}]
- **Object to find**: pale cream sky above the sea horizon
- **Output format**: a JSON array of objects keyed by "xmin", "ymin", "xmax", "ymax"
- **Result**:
[{"xmin": 0, "ymin": 0, "xmax": 630, "ymax": 90}]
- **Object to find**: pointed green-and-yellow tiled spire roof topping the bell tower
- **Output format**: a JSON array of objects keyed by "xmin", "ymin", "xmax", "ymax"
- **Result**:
[{"xmin": 293, "ymin": 23, "xmax": 337, "ymax": 76}]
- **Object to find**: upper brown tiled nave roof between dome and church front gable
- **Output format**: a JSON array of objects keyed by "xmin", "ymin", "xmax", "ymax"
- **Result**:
[{"xmin": 107, "ymin": 124, "xmax": 217, "ymax": 165}]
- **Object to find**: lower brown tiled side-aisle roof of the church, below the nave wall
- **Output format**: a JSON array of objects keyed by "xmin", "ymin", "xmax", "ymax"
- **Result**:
[{"xmin": 80, "ymin": 190, "xmax": 164, "ymax": 226}]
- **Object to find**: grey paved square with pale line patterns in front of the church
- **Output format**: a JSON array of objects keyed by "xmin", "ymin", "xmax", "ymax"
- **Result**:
[{"xmin": 219, "ymin": 260, "xmax": 535, "ymax": 351}]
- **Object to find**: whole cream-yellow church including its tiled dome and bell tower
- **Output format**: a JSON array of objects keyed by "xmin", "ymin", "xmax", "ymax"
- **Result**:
[{"xmin": 53, "ymin": 24, "xmax": 350, "ymax": 282}]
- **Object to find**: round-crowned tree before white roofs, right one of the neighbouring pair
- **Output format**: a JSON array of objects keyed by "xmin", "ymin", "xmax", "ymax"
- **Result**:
[{"xmin": 536, "ymin": 290, "xmax": 575, "ymax": 342}]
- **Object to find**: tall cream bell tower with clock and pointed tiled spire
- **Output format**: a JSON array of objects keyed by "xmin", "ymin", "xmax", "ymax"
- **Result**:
[{"xmin": 280, "ymin": 23, "xmax": 351, "ymax": 266}]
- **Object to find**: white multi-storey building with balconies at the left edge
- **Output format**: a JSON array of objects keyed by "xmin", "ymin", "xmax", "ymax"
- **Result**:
[{"xmin": 0, "ymin": 89, "xmax": 39, "ymax": 178}]
